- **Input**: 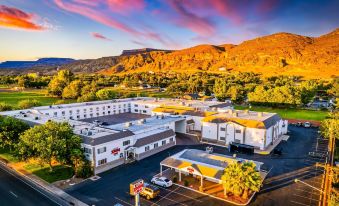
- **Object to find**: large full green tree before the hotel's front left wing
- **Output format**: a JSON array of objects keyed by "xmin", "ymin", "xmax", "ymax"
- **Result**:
[{"xmin": 18, "ymin": 121, "xmax": 81, "ymax": 171}]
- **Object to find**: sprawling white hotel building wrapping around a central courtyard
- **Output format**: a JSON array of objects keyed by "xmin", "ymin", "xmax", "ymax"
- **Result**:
[{"xmin": 0, "ymin": 98, "xmax": 287, "ymax": 174}]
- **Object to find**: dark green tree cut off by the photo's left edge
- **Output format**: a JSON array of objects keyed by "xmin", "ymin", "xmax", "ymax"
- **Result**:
[{"xmin": 0, "ymin": 116, "xmax": 29, "ymax": 150}]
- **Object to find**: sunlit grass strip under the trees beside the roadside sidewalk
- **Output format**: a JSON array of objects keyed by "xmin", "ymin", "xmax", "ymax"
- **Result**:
[{"xmin": 0, "ymin": 148, "xmax": 73, "ymax": 183}]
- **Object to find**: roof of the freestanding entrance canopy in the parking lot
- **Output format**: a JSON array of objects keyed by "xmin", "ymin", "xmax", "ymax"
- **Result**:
[{"xmin": 160, "ymin": 149, "xmax": 263, "ymax": 181}]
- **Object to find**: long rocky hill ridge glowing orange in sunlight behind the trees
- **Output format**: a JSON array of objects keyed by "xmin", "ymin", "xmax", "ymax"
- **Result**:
[{"xmin": 0, "ymin": 29, "xmax": 339, "ymax": 78}]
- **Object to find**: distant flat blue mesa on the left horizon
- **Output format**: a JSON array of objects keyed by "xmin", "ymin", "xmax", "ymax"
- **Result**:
[{"xmin": 0, "ymin": 58, "xmax": 75, "ymax": 69}]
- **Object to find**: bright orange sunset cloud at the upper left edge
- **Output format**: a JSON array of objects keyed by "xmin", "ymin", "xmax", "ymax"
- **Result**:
[{"xmin": 0, "ymin": 5, "xmax": 46, "ymax": 31}]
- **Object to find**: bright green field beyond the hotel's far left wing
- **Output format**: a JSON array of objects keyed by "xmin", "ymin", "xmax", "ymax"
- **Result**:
[{"xmin": 0, "ymin": 90, "xmax": 75, "ymax": 107}]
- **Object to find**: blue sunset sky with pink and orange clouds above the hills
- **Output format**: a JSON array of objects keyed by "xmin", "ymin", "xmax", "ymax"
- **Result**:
[{"xmin": 0, "ymin": 0, "xmax": 339, "ymax": 61}]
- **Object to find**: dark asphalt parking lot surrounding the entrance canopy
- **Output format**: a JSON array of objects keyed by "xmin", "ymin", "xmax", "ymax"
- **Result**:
[{"xmin": 67, "ymin": 126, "xmax": 327, "ymax": 206}]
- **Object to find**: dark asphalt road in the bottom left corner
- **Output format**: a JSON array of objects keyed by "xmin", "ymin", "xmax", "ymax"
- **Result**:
[{"xmin": 0, "ymin": 166, "xmax": 59, "ymax": 206}]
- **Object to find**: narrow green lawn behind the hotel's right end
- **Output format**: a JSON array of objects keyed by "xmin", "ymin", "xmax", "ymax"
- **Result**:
[{"xmin": 234, "ymin": 105, "xmax": 328, "ymax": 121}]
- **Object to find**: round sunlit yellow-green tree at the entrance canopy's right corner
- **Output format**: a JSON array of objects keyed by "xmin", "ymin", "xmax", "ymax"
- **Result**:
[{"xmin": 221, "ymin": 162, "xmax": 262, "ymax": 199}]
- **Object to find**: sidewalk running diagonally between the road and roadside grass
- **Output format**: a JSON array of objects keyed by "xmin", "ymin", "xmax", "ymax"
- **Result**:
[{"xmin": 0, "ymin": 161, "xmax": 87, "ymax": 206}]
